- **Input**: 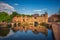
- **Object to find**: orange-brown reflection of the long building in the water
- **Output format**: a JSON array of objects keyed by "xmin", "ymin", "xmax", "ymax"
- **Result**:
[{"xmin": 12, "ymin": 26, "xmax": 48, "ymax": 34}]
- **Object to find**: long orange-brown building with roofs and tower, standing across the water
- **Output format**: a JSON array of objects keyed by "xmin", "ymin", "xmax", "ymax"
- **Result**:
[{"xmin": 12, "ymin": 13, "xmax": 48, "ymax": 24}]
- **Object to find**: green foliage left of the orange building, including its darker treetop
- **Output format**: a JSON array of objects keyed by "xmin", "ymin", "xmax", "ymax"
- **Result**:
[{"xmin": 0, "ymin": 12, "xmax": 20, "ymax": 22}]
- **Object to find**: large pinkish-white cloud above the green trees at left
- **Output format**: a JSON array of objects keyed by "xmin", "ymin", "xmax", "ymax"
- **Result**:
[{"xmin": 0, "ymin": 3, "xmax": 15, "ymax": 13}]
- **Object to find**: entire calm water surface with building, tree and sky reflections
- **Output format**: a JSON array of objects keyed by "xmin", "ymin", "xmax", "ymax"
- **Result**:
[{"xmin": 0, "ymin": 25, "xmax": 53, "ymax": 40}]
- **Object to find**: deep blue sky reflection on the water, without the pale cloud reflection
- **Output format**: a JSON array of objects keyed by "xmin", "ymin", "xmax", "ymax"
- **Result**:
[{"xmin": 1, "ymin": 30, "xmax": 53, "ymax": 40}]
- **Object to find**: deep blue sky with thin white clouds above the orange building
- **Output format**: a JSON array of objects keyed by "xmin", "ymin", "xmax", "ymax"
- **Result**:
[{"xmin": 0, "ymin": 0, "xmax": 60, "ymax": 15}]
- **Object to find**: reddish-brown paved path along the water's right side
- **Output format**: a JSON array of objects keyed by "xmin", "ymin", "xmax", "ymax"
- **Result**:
[{"xmin": 50, "ymin": 23, "xmax": 60, "ymax": 40}]
